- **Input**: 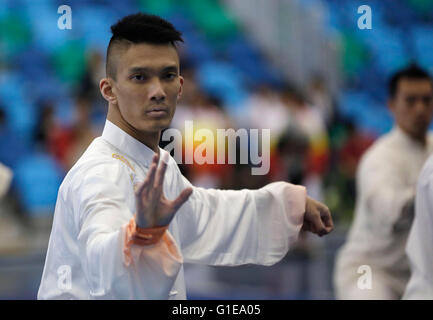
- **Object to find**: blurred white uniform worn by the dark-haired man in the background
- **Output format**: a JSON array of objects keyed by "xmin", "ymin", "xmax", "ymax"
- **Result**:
[{"xmin": 334, "ymin": 126, "xmax": 433, "ymax": 299}]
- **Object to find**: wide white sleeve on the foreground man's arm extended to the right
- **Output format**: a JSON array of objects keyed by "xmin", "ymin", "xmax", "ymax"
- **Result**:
[{"xmin": 176, "ymin": 169, "xmax": 306, "ymax": 266}]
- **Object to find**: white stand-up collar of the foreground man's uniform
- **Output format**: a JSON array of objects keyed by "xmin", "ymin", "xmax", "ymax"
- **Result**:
[{"xmin": 101, "ymin": 120, "xmax": 157, "ymax": 167}]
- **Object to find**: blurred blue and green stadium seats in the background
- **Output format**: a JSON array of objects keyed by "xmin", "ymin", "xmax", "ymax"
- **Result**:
[{"xmin": 0, "ymin": 0, "xmax": 433, "ymax": 218}]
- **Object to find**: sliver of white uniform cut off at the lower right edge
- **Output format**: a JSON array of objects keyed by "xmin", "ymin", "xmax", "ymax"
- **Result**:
[{"xmin": 403, "ymin": 152, "xmax": 433, "ymax": 299}]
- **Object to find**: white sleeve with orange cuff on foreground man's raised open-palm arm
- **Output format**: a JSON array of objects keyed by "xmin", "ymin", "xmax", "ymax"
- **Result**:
[{"xmin": 75, "ymin": 166, "xmax": 182, "ymax": 299}]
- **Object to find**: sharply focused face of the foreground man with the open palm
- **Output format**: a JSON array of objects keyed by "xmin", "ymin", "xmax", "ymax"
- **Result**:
[{"xmin": 112, "ymin": 43, "xmax": 183, "ymax": 132}]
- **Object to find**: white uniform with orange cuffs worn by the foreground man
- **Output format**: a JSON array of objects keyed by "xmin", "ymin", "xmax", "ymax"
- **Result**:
[{"xmin": 38, "ymin": 120, "xmax": 306, "ymax": 299}]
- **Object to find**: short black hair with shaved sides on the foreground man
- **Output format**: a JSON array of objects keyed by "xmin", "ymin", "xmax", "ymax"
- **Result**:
[{"xmin": 105, "ymin": 12, "xmax": 183, "ymax": 79}]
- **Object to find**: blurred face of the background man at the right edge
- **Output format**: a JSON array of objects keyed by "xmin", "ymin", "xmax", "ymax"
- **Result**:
[{"xmin": 389, "ymin": 78, "xmax": 433, "ymax": 139}]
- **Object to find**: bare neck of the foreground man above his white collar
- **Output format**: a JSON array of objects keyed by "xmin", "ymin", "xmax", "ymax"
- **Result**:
[{"xmin": 107, "ymin": 104, "xmax": 161, "ymax": 154}]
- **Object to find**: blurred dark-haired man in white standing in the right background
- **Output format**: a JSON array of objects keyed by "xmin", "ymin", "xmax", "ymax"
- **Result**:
[{"xmin": 334, "ymin": 65, "xmax": 433, "ymax": 299}]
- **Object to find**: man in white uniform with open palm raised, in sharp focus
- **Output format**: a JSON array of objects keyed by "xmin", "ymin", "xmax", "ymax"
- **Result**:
[{"xmin": 38, "ymin": 14, "xmax": 333, "ymax": 299}]
